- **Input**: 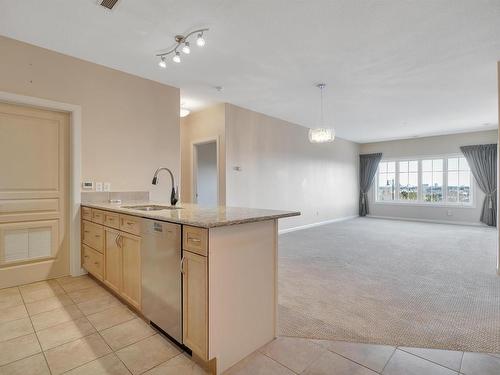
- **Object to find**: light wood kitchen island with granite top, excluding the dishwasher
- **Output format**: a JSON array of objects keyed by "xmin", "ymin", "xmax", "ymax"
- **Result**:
[{"xmin": 82, "ymin": 202, "xmax": 300, "ymax": 374}]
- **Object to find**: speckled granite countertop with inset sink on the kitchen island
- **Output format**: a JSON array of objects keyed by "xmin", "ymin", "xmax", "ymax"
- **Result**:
[{"xmin": 82, "ymin": 201, "xmax": 300, "ymax": 228}]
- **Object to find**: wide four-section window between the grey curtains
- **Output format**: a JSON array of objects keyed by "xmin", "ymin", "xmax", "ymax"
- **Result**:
[{"xmin": 375, "ymin": 155, "xmax": 473, "ymax": 206}]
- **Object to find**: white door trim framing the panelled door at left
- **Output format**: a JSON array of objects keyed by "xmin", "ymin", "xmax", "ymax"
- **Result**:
[{"xmin": 0, "ymin": 91, "xmax": 85, "ymax": 276}]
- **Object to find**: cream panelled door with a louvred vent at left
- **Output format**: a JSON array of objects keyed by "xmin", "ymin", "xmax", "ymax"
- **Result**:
[{"xmin": 0, "ymin": 103, "xmax": 70, "ymax": 288}]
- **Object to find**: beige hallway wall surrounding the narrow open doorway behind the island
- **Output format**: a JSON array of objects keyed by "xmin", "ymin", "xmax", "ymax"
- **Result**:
[{"xmin": 181, "ymin": 104, "xmax": 226, "ymax": 205}]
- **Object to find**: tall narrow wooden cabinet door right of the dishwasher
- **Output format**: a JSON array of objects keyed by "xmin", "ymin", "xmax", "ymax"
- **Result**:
[{"xmin": 182, "ymin": 251, "xmax": 208, "ymax": 360}]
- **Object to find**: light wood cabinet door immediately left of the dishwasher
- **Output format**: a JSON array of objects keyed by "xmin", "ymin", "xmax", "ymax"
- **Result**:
[{"xmin": 119, "ymin": 232, "xmax": 142, "ymax": 310}]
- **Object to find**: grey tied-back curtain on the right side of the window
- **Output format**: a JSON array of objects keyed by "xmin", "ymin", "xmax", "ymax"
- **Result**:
[{"xmin": 460, "ymin": 144, "xmax": 497, "ymax": 226}]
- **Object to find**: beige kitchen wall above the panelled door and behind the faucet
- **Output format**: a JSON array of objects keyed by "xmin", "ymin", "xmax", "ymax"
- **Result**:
[{"xmin": 0, "ymin": 37, "xmax": 180, "ymax": 203}]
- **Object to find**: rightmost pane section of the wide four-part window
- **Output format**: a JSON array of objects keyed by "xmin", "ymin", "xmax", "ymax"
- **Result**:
[{"xmin": 447, "ymin": 157, "xmax": 471, "ymax": 203}]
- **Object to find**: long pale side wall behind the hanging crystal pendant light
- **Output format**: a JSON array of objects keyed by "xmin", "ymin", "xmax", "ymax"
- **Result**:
[{"xmin": 226, "ymin": 104, "xmax": 359, "ymax": 229}]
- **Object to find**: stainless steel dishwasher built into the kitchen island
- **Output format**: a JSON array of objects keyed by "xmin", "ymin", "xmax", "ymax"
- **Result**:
[{"xmin": 141, "ymin": 219, "xmax": 182, "ymax": 344}]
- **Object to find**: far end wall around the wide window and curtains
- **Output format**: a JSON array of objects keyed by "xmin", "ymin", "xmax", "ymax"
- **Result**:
[{"xmin": 361, "ymin": 130, "xmax": 498, "ymax": 224}]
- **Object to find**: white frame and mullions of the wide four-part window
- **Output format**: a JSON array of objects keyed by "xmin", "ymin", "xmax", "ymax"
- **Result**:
[{"xmin": 373, "ymin": 153, "xmax": 476, "ymax": 208}]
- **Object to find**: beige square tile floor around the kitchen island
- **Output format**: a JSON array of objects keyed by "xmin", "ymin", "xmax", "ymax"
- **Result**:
[{"xmin": 0, "ymin": 276, "xmax": 500, "ymax": 375}]
